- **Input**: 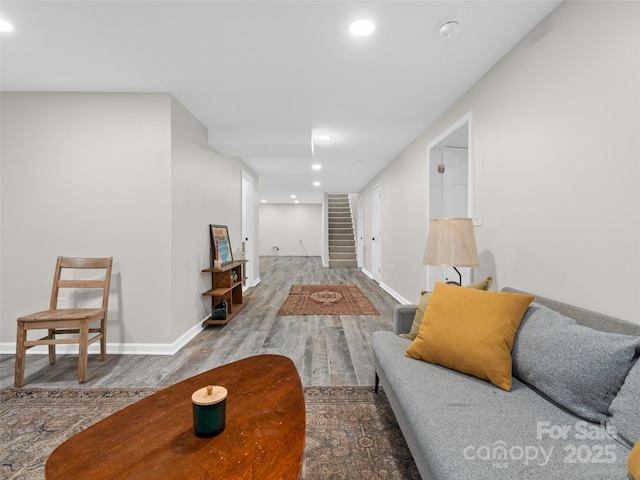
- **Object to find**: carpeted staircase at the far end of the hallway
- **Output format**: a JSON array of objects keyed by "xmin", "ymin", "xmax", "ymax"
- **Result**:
[{"xmin": 328, "ymin": 194, "xmax": 358, "ymax": 267}]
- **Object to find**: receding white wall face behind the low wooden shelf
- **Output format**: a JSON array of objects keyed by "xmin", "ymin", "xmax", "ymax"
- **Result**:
[{"xmin": 171, "ymin": 99, "xmax": 259, "ymax": 339}]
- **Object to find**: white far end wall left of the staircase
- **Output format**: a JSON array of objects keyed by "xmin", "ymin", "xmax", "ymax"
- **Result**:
[{"xmin": 259, "ymin": 203, "xmax": 322, "ymax": 257}]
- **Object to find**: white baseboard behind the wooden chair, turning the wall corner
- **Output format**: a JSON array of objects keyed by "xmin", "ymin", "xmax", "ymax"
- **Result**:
[{"xmin": 0, "ymin": 318, "xmax": 205, "ymax": 355}]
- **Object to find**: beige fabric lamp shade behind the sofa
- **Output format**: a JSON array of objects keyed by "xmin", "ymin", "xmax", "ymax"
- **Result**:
[{"xmin": 424, "ymin": 218, "xmax": 480, "ymax": 267}]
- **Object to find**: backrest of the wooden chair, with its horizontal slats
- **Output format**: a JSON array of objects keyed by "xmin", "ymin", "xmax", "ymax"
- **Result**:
[{"xmin": 49, "ymin": 257, "xmax": 113, "ymax": 312}]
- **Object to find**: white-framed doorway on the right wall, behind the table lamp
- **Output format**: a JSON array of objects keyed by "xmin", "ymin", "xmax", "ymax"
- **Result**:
[{"xmin": 427, "ymin": 112, "xmax": 473, "ymax": 290}]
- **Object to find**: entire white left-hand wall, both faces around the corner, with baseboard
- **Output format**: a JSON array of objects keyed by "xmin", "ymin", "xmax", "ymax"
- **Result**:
[{"xmin": 0, "ymin": 93, "xmax": 257, "ymax": 353}]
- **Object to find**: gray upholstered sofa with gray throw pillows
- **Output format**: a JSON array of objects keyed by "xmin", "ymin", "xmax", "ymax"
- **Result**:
[{"xmin": 372, "ymin": 288, "xmax": 640, "ymax": 480}]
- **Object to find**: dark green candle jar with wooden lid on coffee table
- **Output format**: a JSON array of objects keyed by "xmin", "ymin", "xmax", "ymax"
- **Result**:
[{"xmin": 191, "ymin": 385, "xmax": 227, "ymax": 437}]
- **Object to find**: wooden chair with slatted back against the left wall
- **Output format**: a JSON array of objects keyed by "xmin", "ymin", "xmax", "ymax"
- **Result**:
[{"xmin": 15, "ymin": 257, "xmax": 113, "ymax": 387}]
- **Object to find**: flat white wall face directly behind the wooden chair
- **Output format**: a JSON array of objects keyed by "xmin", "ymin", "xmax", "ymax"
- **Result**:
[{"xmin": 0, "ymin": 93, "xmax": 171, "ymax": 343}]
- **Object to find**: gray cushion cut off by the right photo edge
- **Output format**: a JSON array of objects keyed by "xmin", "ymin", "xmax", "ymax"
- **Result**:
[{"xmin": 609, "ymin": 360, "xmax": 640, "ymax": 446}]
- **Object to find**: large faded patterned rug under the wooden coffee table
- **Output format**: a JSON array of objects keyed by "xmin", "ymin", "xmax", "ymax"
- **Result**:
[{"xmin": 0, "ymin": 387, "xmax": 420, "ymax": 480}]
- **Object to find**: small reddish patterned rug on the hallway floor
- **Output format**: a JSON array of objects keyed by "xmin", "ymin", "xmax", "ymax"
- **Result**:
[{"xmin": 278, "ymin": 285, "xmax": 379, "ymax": 315}]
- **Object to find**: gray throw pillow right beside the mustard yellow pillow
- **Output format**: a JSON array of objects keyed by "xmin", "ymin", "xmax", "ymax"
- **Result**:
[{"xmin": 513, "ymin": 303, "xmax": 640, "ymax": 422}]
